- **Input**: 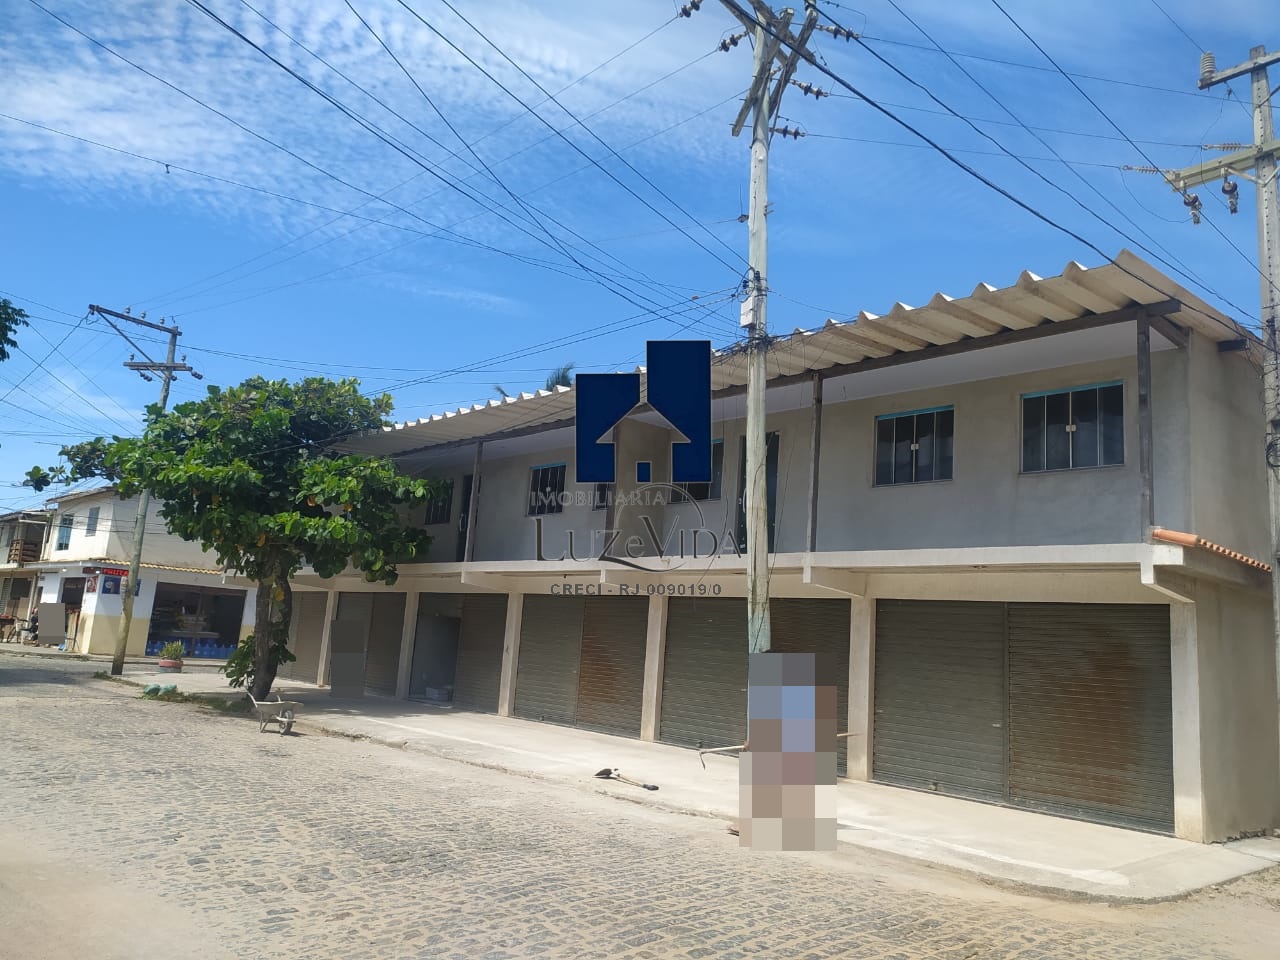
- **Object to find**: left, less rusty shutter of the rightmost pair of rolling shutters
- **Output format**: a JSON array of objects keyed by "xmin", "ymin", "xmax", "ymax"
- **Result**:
[{"xmin": 872, "ymin": 600, "xmax": 1005, "ymax": 800}]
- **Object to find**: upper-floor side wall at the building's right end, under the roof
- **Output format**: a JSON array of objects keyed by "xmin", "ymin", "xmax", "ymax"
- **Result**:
[{"xmin": 1183, "ymin": 337, "xmax": 1271, "ymax": 558}]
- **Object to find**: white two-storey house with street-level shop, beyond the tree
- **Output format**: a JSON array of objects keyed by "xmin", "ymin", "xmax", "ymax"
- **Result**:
[{"xmin": 31, "ymin": 486, "xmax": 255, "ymax": 659}]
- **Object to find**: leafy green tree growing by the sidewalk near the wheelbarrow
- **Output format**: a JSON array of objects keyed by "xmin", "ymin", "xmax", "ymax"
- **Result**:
[{"xmin": 27, "ymin": 378, "xmax": 439, "ymax": 699}]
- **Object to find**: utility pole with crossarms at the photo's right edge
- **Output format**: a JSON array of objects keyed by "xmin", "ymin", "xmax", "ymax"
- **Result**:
[{"xmin": 1165, "ymin": 46, "xmax": 1280, "ymax": 768}]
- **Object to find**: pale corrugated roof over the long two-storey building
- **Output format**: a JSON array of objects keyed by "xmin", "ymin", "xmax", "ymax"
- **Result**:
[{"xmin": 343, "ymin": 250, "xmax": 1257, "ymax": 454}]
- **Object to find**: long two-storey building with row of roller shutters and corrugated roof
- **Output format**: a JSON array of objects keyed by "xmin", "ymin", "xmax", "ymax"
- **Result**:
[{"xmin": 293, "ymin": 252, "xmax": 1280, "ymax": 841}]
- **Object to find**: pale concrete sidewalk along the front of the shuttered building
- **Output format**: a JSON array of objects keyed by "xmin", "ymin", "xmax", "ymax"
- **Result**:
[{"xmin": 124, "ymin": 669, "xmax": 1280, "ymax": 901}]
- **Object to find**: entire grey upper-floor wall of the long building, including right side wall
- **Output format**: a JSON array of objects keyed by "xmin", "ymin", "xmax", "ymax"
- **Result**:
[{"xmin": 404, "ymin": 335, "xmax": 1267, "ymax": 562}]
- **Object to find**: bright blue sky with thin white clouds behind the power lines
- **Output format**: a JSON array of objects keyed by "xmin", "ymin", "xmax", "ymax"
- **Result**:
[{"xmin": 0, "ymin": 0, "xmax": 1280, "ymax": 509}]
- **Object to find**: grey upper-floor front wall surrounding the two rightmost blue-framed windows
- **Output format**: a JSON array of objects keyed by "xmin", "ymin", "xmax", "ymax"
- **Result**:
[{"xmin": 818, "ymin": 358, "xmax": 1140, "ymax": 550}]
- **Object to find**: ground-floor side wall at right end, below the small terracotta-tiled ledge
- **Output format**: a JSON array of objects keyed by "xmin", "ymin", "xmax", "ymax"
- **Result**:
[{"xmin": 1174, "ymin": 582, "xmax": 1280, "ymax": 841}]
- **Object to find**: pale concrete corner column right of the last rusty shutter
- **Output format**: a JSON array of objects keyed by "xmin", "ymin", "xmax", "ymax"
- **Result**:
[{"xmin": 1169, "ymin": 602, "xmax": 1206, "ymax": 844}]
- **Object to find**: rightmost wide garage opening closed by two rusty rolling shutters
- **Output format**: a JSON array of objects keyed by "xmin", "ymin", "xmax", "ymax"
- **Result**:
[{"xmin": 873, "ymin": 600, "xmax": 1174, "ymax": 832}]
